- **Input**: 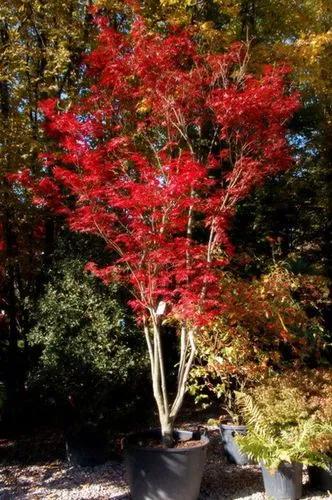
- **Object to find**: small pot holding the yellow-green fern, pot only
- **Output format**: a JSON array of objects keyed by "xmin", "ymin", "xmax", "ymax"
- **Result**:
[{"xmin": 262, "ymin": 462, "xmax": 302, "ymax": 500}]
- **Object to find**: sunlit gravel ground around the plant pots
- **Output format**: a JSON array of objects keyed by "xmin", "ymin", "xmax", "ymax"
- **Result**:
[{"xmin": 0, "ymin": 432, "xmax": 332, "ymax": 500}]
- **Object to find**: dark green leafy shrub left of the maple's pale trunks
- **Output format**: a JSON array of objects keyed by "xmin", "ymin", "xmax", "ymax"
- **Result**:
[{"xmin": 28, "ymin": 259, "xmax": 146, "ymax": 426}]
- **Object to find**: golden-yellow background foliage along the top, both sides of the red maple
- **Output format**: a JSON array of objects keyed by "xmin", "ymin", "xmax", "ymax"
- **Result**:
[{"xmin": 0, "ymin": 0, "xmax": 332, "ymax": 179}]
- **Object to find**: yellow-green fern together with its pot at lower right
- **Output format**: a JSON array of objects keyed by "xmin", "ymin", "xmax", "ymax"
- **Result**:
[{"xmin": 237, "ymin": 376, "xmax": 332, "ymax": 500}]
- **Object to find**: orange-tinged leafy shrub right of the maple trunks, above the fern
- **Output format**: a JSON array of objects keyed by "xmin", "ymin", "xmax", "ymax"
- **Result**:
[{"xmin": 189, "ymin": 264, "xmax": 328, "ymax": 421}]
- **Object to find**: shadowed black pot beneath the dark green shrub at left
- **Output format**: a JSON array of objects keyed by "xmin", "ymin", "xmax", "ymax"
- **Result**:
[{"xmin": 65, "ymin": 425, "xmax": 108, "ymax": 467}]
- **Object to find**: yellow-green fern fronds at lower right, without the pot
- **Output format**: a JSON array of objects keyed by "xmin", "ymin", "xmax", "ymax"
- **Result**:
[{"xmin": 237, "ymin": 372, "xmax": 332, "ymax": 470}]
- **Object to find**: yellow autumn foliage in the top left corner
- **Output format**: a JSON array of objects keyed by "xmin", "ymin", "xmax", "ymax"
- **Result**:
[{"xmin": 0, "ymin": 0, "xmax": 91, "ymax": 171}]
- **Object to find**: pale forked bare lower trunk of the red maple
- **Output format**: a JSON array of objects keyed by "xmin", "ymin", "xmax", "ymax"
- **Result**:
[{"xmin": 144, "ymin": 311, "xmax": 196, "ymax": 447}]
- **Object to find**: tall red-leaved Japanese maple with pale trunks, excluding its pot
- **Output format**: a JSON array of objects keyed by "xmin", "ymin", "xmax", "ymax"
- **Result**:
[{"xmin": 27, "ymin": 15, "xmax": 298, "ymax": 444}]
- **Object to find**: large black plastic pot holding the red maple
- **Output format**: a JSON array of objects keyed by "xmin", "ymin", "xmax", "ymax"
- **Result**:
[{"xmin": 125, "ymin": 430, "xmax": 209, "ymax": 500}]
